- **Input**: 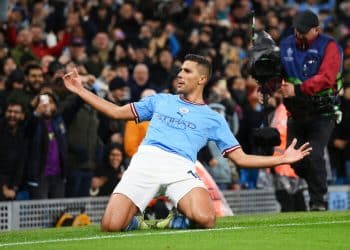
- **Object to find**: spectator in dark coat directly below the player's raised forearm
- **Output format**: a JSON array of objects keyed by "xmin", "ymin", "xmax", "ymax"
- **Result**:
[{"xmin": 62, "ymin": 81, "xmax": 102, "ymax": 197}]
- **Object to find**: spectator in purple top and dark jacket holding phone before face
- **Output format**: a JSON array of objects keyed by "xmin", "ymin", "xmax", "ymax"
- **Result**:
[{"xmin": 26, "ymin": 91, "xmax": 68, "ymax": 199}]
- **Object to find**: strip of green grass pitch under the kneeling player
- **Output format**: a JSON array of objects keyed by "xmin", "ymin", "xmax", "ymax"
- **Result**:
[{"xmin": 0, "ymin": 211, "xmax": 350, "ymax": 250}]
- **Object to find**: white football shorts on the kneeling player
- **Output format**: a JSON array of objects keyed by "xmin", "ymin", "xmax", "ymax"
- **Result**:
[{"xmin": 113, "ymin": 145, "xmax": 207, "ymax": 212}]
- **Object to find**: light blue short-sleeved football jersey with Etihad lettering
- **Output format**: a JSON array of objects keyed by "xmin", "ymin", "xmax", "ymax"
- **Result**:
[{"xmin": 131, "ymin": 94, "xmax": 240, "ymax": 162}]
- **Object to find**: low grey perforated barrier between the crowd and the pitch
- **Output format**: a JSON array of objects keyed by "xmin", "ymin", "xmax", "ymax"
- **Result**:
[{"xmin": 0, "ymin": 186, "xmax": 350, "ymax": 231}]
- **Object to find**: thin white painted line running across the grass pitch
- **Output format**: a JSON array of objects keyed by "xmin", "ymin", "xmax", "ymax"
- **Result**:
[{"xmin": 0, "ymin": 220, "xmax": 350, "ymax": 247}]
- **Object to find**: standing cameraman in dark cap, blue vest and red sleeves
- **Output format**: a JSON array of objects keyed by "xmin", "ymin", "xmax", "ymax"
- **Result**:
[{"xmin": 280, "ymin": 10, "xmax": 342, "ymax": 211}]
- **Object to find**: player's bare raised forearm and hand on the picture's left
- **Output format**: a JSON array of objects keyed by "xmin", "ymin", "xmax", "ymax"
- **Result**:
[{"xmin": 63, "ymin": 69, "xmax": 135, "ymax": 120}]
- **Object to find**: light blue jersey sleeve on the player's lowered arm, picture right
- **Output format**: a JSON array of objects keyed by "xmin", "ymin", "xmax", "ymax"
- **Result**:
[{"xmin": 210, "ymin": 116, "xmax": 241, "ymax": 157}]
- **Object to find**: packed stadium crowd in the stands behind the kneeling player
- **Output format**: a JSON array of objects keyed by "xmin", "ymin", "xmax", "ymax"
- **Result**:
[{"xmin": 0, "ymin": 0, "xmax": 350, "ymax": 204}]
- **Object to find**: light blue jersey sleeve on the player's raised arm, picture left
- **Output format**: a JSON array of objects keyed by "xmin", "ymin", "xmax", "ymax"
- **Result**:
[{"xmin": 131, "ymin": 95, "xmax": 157, "ymax": 122}]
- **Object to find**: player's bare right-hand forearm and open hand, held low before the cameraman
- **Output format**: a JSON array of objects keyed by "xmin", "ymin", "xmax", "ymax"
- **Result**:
[{"xmin": 228, "ymin": 139, "xmax": 312, "ymax": 168}]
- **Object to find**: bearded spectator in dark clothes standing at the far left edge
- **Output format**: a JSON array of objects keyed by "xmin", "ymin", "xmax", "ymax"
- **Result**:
[{"xmin": 0, "ymin": 100, "xmax": 27, "ymax": 201}]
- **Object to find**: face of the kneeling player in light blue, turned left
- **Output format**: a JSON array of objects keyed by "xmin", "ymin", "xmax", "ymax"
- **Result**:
[{"xmin": 175, "ymin": 61, "xmax": 201, "ymax": 94}]
